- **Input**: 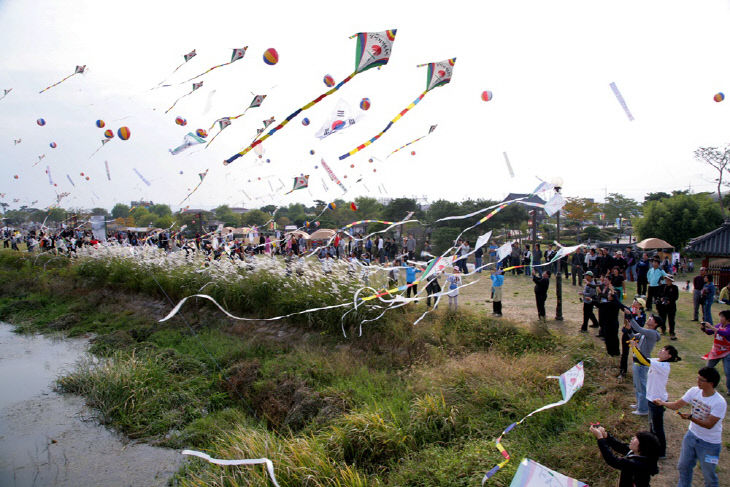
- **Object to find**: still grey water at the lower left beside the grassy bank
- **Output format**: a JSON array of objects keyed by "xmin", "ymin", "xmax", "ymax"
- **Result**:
[{"xmin": 0, "ymin": 323, "xmax": 183, "ymax": 487}]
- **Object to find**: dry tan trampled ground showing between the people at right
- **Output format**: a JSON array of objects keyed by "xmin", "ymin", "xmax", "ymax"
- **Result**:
[{"xmin": 459, "ymin": 266, "xmax": 730, "ymax": 486}]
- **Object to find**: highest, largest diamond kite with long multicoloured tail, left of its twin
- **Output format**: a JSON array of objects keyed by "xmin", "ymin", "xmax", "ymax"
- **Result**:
[{"xmin": 224, "ymin": 29, "xmax": 396, "ymax": 165}]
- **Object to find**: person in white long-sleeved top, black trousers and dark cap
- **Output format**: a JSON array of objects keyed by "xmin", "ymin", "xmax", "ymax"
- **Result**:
[{"xmin": 646, "ymin": 345, "xmax": 682, "ymax": 458}]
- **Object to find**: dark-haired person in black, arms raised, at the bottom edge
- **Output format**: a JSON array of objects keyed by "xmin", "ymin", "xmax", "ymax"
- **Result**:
[{"xmin": 590, "ymin": 425, "xmax": 659, "ymax": 487}]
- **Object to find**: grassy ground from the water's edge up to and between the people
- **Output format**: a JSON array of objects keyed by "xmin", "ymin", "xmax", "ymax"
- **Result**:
[{"xmin": 0, "ymin": 252, "xmax": 730, "ymax": 487}]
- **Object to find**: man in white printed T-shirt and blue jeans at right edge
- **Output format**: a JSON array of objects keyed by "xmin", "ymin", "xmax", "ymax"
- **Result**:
[{"xmin": 656, "ymin": 367, "xmax": 727, "ymax": 487}]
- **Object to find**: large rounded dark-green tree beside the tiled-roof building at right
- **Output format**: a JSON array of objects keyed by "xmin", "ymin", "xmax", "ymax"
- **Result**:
[{"xmin": 634, "ymin": 193, "xmax": 723, "ymax": 249}]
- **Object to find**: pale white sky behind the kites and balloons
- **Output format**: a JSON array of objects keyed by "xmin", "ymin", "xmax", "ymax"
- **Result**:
[{"xmin": 0, "ymin": 0, "xmax": 730, "ymax": 213}]
